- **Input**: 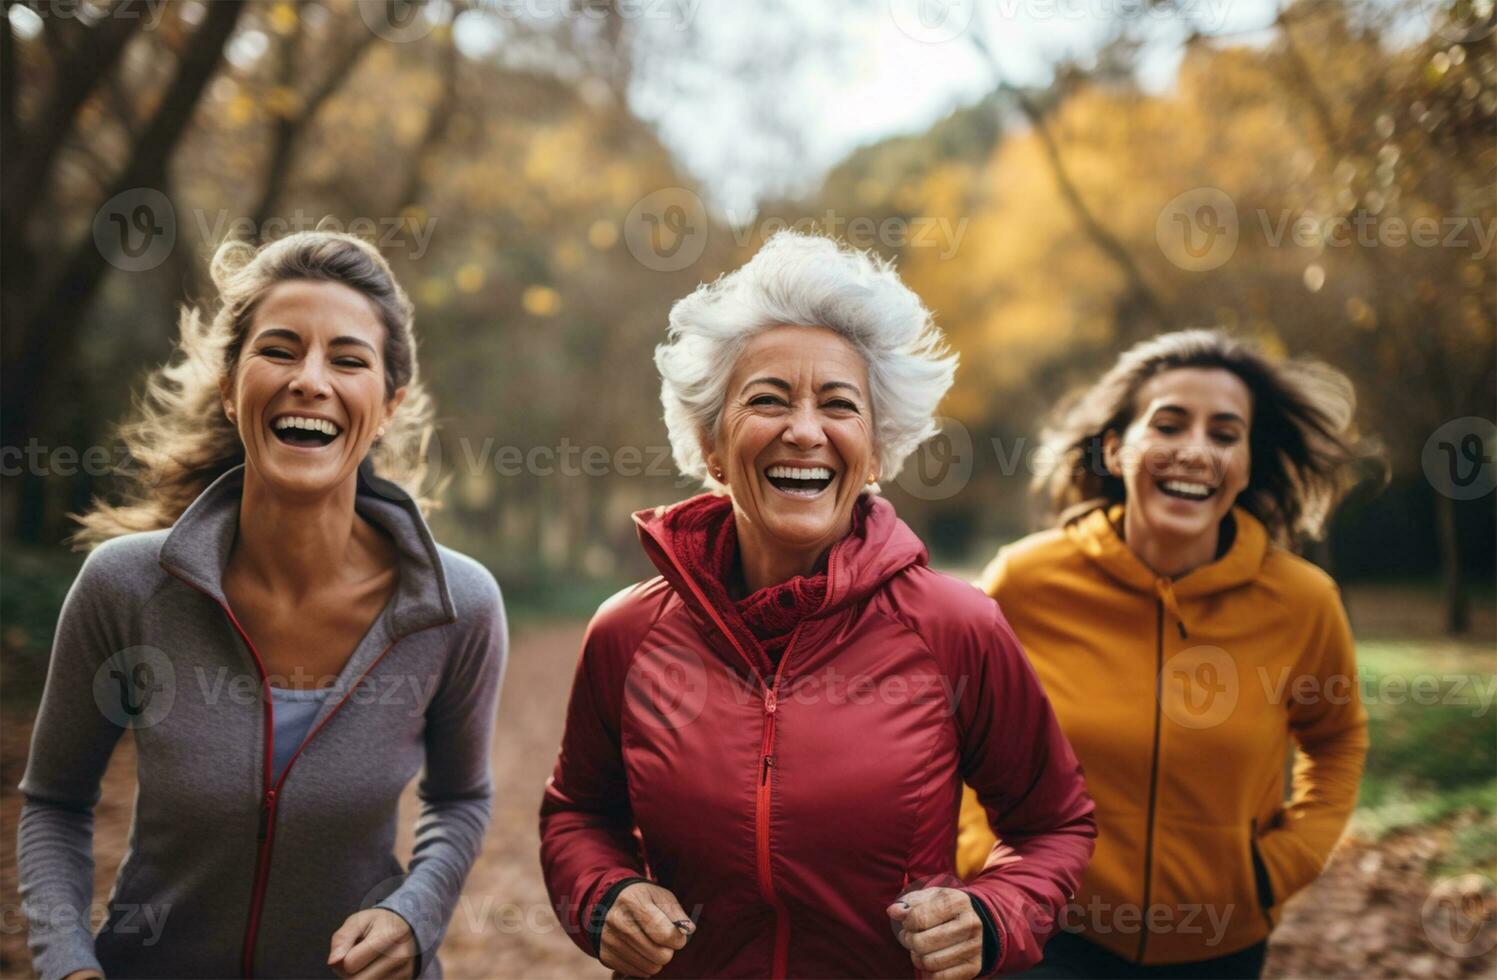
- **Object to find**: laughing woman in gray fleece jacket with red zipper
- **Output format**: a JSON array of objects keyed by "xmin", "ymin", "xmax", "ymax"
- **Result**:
[{"xmin": 18, "ymin": 232, "xmax": 506, "ymax": 977}]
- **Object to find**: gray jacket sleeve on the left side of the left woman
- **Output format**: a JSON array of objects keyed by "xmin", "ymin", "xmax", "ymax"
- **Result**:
[{"xmin": 16, "ymin": 545, "xmax": 129, "ymax": 980}]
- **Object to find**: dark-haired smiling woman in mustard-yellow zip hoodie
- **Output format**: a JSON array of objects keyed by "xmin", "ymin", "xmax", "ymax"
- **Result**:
[{"xmin": 958, "ymin": 331, "xmax": 1367, "ymax": 977}]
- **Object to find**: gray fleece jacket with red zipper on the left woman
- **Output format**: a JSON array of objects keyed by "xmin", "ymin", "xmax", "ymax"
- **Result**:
[{"xmin": 18, "ymin": 467, "xmax": 506, "ymax": 979}]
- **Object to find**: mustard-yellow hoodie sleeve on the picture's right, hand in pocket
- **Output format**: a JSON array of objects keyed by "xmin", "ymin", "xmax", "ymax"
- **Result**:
[{"xmin": 1257, "ymin": 587, "xmax": 1367, "ymax": 905}]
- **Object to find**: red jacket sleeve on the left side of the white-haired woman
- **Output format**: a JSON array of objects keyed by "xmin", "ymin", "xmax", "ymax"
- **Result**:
[{"xmin": 540, "ymin": 604, "xmax": 647, "ymax": 956}]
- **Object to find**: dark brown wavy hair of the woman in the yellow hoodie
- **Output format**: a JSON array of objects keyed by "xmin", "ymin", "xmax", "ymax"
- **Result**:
[{"xmin": 1031, "ymin": 329, "xmax": 1379, "ymax": 545}]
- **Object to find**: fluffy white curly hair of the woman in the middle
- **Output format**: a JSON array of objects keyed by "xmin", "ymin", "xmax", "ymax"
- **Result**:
[{"xmin": 656, "ymin": 232, "xmax": 957, "ymax": 488}]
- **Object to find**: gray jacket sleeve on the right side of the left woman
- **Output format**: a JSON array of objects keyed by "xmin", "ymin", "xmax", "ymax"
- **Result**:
[{"xmin": 376, "ymin": 572, "xmax": 509, "ymax": 977}]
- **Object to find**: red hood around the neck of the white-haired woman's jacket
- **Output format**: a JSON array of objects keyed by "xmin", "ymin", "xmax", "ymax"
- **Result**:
[{"xmin": 635, "ymin": 494, "xmax": 928, "ymax": 676}]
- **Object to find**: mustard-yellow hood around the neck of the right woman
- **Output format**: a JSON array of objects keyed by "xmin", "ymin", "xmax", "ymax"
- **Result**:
[{"xmin": 1066, "ymin": 504, "xmax": 1268, "ymax": 598}]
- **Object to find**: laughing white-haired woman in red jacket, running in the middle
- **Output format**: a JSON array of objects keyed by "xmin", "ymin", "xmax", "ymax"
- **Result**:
[{"xmin": 540, "ymin": 233, "xmax": 1096, "ymax": 980}]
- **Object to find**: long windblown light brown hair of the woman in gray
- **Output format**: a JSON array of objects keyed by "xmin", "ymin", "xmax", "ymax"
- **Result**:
[{"xmin": 72, "ymin": 230, "xmax": 434, "ymax": 548}]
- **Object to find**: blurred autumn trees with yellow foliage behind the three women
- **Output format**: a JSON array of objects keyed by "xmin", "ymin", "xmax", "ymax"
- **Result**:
[{"xmin": 0, "ymin": 0, "xmax": 1497, "ymax": 630}]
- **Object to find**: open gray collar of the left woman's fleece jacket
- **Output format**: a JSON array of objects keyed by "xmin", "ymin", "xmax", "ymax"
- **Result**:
[{"xmin": 160, "ymin": 462, "xmax": 457, "ymax": 636}]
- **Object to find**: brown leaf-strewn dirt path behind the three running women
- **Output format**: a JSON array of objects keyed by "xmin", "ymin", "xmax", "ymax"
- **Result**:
[{"xmin": 0, "ymin": 624, "xmax": 1497, "ymax": 979}]
